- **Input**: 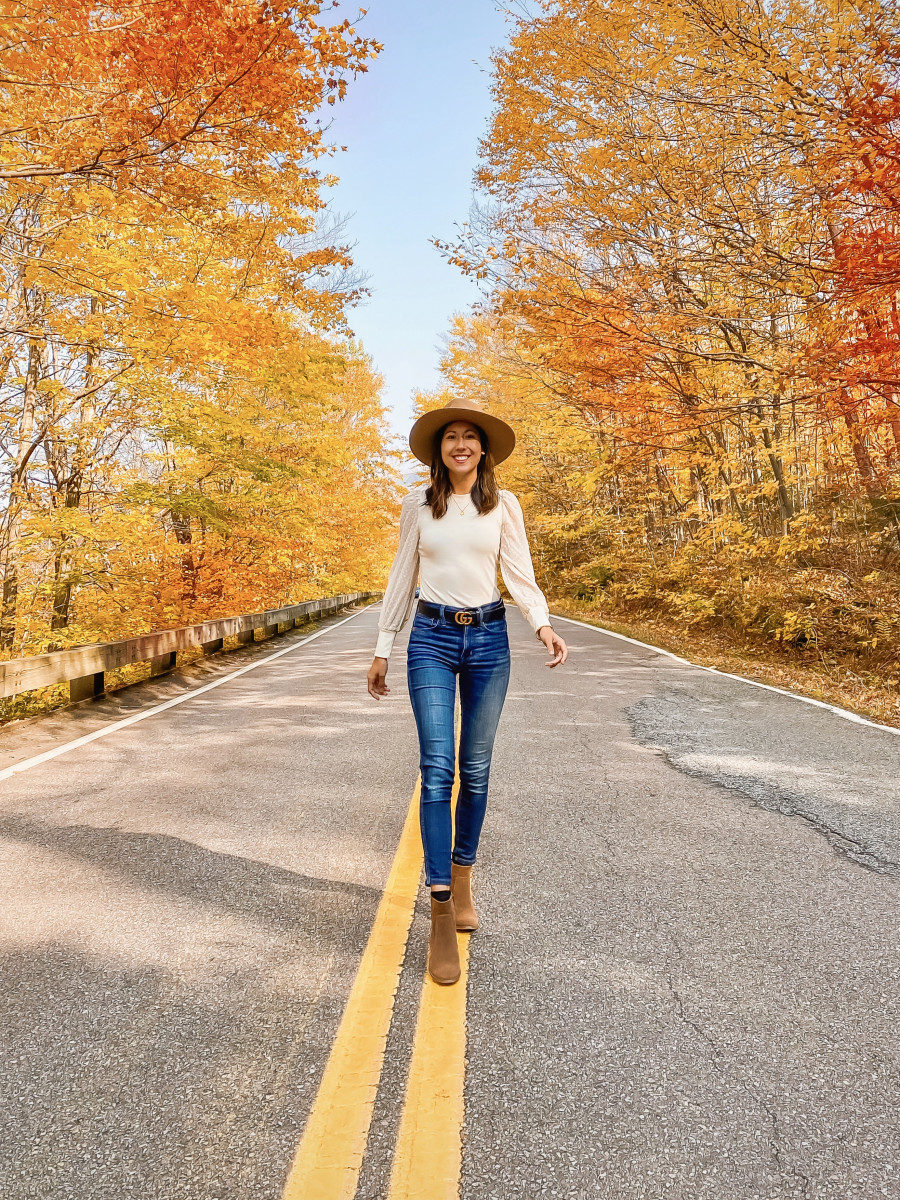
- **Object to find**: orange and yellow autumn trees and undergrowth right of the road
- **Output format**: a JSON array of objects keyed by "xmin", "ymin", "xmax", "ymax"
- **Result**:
[{"xmin": 421, "ymin": 0, "xmax": 900, "ymax": 725}]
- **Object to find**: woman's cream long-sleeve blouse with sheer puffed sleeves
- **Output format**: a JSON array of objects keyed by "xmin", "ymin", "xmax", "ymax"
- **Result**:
[{"xmin": 376, "ymin": 486, "xmax": 550, "ymax": 659}]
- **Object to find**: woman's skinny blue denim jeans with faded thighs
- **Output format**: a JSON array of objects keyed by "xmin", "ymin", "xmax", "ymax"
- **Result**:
[{"xmin": 407, "ymin": 610, "xmax": 509, "ymax": 887}]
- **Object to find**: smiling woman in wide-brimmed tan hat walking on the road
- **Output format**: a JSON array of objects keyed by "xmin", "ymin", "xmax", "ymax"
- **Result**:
[{"xmin": 368, "ymin": 400, "xmax": 569, "ymax": 984}]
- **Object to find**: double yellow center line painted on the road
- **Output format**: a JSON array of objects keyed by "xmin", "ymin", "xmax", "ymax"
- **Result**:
[{"xmin": 282, "ymin": 785, "xmax": 469, "ymax": 1200}]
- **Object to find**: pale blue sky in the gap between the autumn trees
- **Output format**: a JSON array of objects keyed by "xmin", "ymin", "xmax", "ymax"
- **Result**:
[{"xmin": 326, "ymin": 0, "xmax": 506, "ymax": 433}]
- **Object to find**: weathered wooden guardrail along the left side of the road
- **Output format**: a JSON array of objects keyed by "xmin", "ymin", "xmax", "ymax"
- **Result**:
[{"xmin": 0, "ymin": 592, "xmax": 380, "ymax": 703}]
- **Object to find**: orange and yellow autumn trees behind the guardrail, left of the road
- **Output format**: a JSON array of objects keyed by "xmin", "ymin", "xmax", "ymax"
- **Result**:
[{"xmin": 0, "ymin": 0, "xmax": 395, "ymax": 658}]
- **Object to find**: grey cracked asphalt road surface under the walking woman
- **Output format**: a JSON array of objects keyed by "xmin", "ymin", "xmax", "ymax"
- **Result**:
[{"xmin": 0, "ymin": 610, "xmax": 900, "ymax": 1200}]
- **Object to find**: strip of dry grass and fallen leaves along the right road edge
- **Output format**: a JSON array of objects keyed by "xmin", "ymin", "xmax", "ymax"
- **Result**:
[{"xmin": 553, "ymin": 600, "xmax": 900, "ymax": 728}]
